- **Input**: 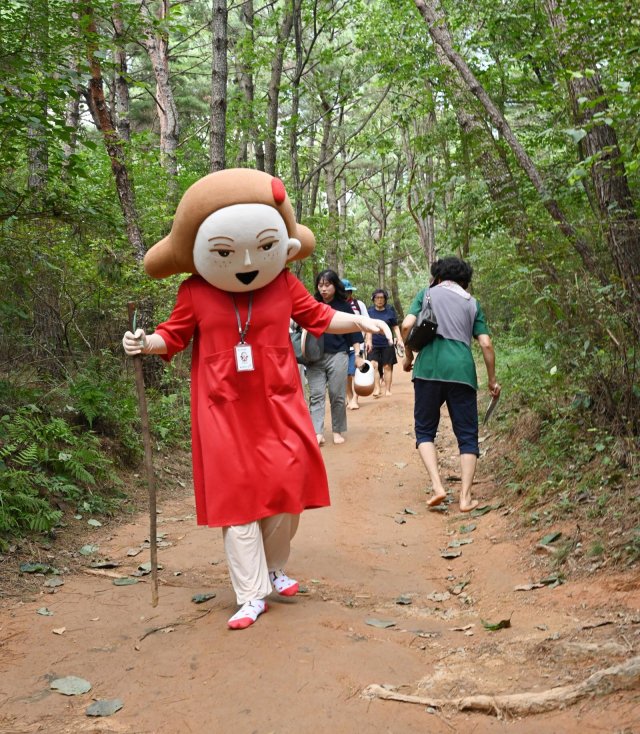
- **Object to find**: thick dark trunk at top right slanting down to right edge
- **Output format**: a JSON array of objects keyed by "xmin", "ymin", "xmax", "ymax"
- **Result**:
[{"xmin": 545, "ymin": 0, "xmax": 640, "ymax": 335}]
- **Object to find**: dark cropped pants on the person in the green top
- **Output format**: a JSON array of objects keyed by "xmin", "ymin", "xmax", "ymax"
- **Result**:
[{"xmin": 413, "ymin": 378, "xmax": 480, "ymax": 456}]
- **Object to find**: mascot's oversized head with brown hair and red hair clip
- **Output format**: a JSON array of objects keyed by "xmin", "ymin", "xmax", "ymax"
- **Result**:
[{"xmin": 144, "ymin": 168, "xmax": 315, "ymax": 293}]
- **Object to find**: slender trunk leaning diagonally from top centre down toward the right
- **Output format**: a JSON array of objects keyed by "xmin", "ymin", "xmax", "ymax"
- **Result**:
[{"xmin": 414, "ymin": 0, "xmax": 608, "ymax": 284}]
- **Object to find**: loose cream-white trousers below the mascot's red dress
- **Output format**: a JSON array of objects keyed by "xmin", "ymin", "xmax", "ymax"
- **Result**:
[{"xmin": 222, "ymin": 513, "xmax": 300, "ymax": 604}]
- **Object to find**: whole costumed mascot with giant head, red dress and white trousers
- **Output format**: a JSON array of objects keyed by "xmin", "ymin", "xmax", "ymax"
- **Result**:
[{"xmin": 123, "ymin": 169, "xmax": 391, "ymax": 629}]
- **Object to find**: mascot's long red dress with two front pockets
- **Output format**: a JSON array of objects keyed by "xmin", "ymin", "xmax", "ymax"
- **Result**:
[{"xmin": 155, "ymin": 269, "xmax": 335, "ymax": 527}]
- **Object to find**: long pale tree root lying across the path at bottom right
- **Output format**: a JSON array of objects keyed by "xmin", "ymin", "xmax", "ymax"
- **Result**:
[{"xmin": 361, "ymin": 656, "xmax": 640, "ymax": 716}]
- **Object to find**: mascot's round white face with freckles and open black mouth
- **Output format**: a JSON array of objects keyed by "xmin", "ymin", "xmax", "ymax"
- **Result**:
[{"xmin": 193, "ymin": 204, "xmax": 301, "ymax": 293}]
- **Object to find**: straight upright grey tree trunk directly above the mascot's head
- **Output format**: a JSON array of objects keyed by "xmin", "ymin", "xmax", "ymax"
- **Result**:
[{"xmin": 209, "ymin": 0, "xmax": 227, "ymax": 173}]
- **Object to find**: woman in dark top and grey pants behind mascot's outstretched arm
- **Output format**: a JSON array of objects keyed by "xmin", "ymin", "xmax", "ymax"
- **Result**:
[{"xmin": 307, "ymin": 270, "xmax": 362, "ymax": 446}]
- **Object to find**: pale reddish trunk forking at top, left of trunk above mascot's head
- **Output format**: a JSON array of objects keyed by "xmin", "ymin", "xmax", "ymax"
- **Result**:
[{"xmin": 140, "ymin": 0, "xmax": 180, "ymax": 184}]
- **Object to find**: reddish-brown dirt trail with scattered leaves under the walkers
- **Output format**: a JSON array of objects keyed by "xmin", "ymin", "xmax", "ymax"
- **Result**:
[{"xmin": 0, "ymin": 370, "xmax": 640, "ymax": 734}]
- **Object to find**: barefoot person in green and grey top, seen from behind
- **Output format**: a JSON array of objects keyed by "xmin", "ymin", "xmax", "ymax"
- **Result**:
[{"xmin": 402, "ymin": 257, "xmax": 500, "ymax": 512}]
